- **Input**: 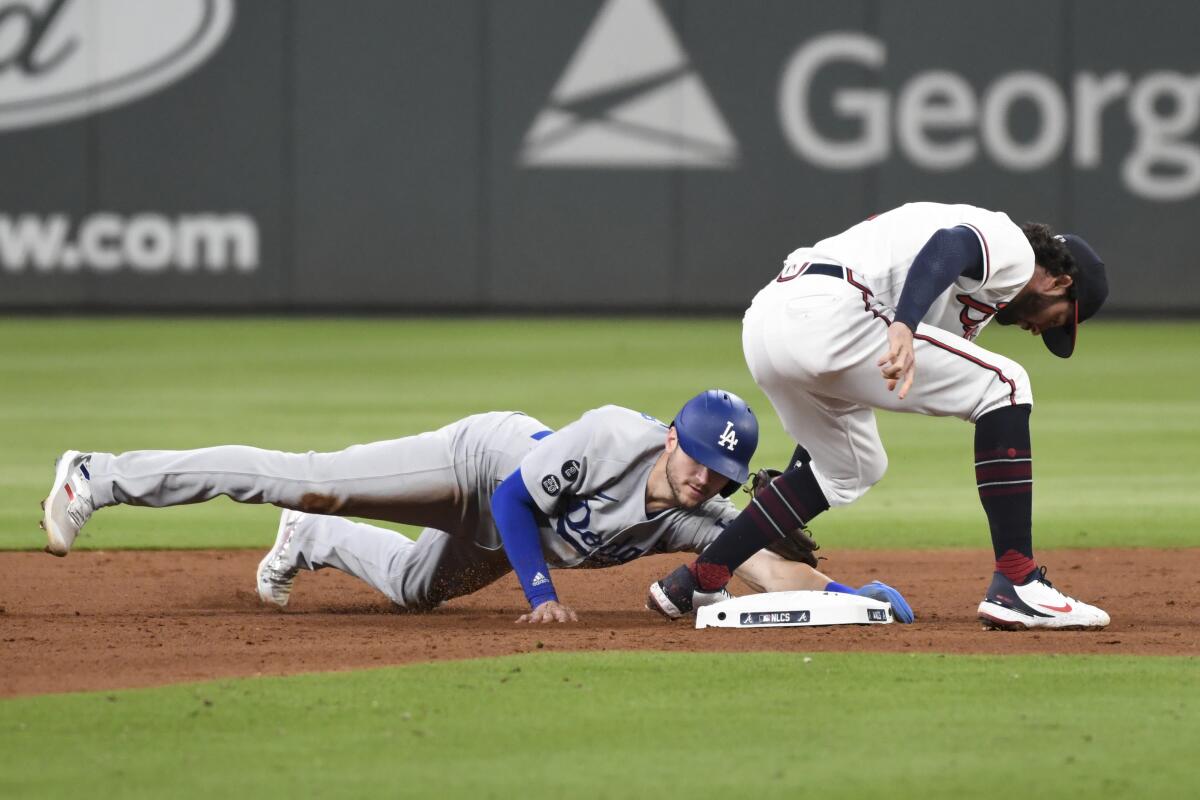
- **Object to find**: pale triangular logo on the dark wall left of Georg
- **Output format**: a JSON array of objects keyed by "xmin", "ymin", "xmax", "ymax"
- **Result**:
[{"xmin": 520, "ymin": 0, "xmax": 738, "ymax": 169}]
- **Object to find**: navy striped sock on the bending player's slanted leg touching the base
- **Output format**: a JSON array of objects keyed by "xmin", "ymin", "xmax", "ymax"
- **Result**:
[{"xmin": 690, "ymin": 464, "xmax": 829, "ymax": 591}]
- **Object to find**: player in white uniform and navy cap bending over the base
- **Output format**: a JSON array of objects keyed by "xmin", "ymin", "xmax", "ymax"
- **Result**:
[{"xmin": 648, "ymin": 203, "xmax": 1109, "ymax": 630}]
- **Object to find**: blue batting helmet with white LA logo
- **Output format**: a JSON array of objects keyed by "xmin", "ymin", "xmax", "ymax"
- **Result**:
[{"xmin": 672, "ymin": 389, "xmax": 758, "ymax": 497}]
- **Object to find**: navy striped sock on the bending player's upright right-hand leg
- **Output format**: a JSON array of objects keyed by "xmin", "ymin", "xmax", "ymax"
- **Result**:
[{"xmin": 976, "ymin": 405, "xmax": 1038, "ymax": 583}]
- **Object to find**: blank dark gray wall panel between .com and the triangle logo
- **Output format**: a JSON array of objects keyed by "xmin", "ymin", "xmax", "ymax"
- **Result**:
[{"xmin": 292, "ymin": 0, "xmax": 482, "ymax": 306}]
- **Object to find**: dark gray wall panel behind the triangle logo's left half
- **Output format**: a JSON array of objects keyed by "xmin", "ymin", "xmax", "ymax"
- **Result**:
[{"xmin": 487, "ymin": 0, "xmax": 679, "ymax": 312}]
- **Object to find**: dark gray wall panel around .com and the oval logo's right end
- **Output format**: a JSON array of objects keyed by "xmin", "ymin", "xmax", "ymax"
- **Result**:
[{"xmin": 85, "ymin": 0, "xmax": 290, "ymax": 307}]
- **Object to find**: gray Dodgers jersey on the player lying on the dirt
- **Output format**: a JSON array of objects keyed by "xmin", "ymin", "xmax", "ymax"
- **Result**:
[{"xmin": 521, "ymin": 405, "xmax": 737, "ymax": 567}]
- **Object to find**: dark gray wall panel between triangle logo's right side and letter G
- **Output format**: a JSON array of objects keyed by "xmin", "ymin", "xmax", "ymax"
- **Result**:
[{"xmin": 672, "ymin": 0, "xmax": 875, "ymax": 303}]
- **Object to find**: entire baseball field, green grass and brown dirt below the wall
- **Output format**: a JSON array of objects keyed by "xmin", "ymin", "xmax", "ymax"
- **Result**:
[{"xmin": 0, "ymin": 318, "xmax": 1200, "ymax": 800}]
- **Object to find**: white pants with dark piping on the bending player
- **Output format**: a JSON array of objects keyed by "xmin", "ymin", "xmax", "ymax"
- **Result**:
[{"xmin": 742, "ymin": 266, "xmax": 1033, "ymax": 506}]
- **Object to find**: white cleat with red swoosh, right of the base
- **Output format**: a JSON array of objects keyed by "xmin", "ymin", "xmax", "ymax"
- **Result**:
[{"xmin": 979, "ymin": 567, "xmax": 1110, "ymax": 631}]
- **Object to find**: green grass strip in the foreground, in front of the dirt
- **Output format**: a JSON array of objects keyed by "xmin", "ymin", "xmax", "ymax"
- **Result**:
[{"xmin": 0, "ymin": 652, "xmax": 1200, "ymax": 800}]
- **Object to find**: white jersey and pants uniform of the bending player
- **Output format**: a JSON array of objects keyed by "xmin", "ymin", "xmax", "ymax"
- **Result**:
[{"xmin": 742, "ymin": 203, "xmax": 1034, "ymax": 506}]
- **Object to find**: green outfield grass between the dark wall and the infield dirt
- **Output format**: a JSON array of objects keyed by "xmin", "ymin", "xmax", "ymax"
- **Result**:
[{"xmin": 0, "ymin": 318, "xmax": 1200, "ymax": 548}]
